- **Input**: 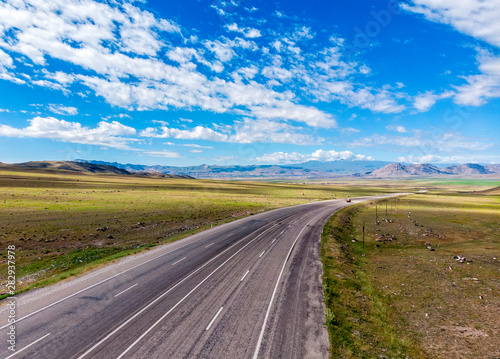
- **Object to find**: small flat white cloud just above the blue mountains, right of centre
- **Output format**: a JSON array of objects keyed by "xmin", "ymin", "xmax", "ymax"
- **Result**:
[{"xmin": 256, "ymin": 150, "xmax": 373, "ymax": 163}]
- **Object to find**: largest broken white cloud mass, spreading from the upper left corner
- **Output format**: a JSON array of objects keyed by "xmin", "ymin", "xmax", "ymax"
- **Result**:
[{"xmin": 0, "ymin": 0, "xmax": 404, "ymax": 127}]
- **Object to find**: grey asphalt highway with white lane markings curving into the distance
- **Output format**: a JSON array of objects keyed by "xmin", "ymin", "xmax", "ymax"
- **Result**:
[{"xmin": 0, "ymin": 196, "xmax": 406, "ymax": 359}]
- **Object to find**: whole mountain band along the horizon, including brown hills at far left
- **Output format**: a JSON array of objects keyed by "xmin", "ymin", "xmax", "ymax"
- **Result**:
[{"xmin": 0, "ymin": 160, "xmax": 500, "ymax": 179}]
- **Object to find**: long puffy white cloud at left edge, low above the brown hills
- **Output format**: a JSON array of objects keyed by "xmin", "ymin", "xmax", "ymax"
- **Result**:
[{"xmin": 0, "ymin": 117, "xmax": 137, "ymax": 150}]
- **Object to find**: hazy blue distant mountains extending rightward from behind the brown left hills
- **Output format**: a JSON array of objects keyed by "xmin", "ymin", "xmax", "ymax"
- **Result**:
[{"xmin": 77, "ymin": 160, "xmax": 500, "ymax": 179}]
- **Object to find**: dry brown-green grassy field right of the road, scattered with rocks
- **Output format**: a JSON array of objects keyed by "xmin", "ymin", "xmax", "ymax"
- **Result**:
[{"xmin": 322, "ymin": 184, "xmax": 500, "ymax": 358}]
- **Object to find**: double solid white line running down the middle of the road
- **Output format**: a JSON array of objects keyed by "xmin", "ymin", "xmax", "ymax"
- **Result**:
[{"xmin": 78, "ymin": 224, "xmax": 277, "ymax": 359}]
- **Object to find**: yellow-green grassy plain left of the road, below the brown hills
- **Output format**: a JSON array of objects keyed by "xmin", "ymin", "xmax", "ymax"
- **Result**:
[{"xmin": 0, "ymin": 171, "xmax": 406, "ymax": 298}]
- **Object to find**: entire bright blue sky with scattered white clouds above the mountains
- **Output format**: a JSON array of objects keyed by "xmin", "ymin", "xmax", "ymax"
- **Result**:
[{"xmin": 0, "ymin": 0, "xmax": 500, "ymax": 165}]
